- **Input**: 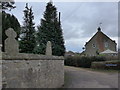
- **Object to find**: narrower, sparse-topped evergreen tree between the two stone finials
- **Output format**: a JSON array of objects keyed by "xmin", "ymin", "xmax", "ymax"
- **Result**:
[{"xmin": 20, "ymin": 4, "xmax": 36, "ymax": 53}]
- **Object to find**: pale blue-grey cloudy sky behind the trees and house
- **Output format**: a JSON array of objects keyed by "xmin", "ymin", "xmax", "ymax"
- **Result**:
[{"xmin": 6, "ymin": 2, "xmax": 118, "ymax": 52}]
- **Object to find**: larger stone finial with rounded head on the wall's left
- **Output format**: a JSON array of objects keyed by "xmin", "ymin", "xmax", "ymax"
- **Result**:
[{"xmin": 5, "ymin": 28, "xmax": 19, "ymax": 54}]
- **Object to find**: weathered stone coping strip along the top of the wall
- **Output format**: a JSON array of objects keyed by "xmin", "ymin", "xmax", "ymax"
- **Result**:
[{"xmin": 0, "ymin": 52, "xmax": 64, "ymax": 60}]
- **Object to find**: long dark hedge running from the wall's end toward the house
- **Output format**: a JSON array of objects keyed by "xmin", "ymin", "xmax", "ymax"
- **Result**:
[{"xmin": 65, "ymin": 56, "xmax": 105, "ymax": 68}]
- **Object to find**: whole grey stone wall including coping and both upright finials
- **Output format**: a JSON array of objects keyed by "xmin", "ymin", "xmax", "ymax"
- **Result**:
[{"xmin": 2, "ymin": 28, "xmax": 64, "ymax": 88}]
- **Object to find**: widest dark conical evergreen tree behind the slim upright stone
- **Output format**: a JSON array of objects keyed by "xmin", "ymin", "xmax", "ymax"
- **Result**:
[{"xmin": 35, "ymin": 2, "xmax": 65, "ymax": 56}]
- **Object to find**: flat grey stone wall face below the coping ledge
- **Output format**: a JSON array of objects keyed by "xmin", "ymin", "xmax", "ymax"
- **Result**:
[{"xmin": 2, "ymin": 60, "xmax": 64, "ymax": 88}]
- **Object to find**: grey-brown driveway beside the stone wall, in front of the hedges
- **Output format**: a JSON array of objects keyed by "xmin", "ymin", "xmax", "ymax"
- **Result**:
[{"xmin": 64, "ymin": 66, "xmax": 118, "ymax": 88}]
